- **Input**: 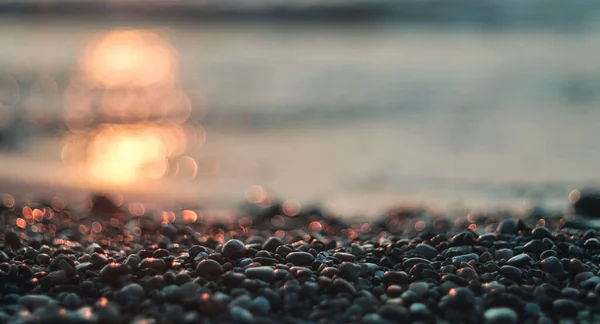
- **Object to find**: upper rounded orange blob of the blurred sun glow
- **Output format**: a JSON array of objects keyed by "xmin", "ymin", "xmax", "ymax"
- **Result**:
[{"xmin": 80, "ymin": 29, "xmax": 177, "ymax": 88}]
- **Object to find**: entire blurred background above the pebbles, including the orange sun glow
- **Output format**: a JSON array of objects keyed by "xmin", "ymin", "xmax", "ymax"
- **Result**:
[{"xmin": 0, "ymin": 0, "xmax": 600, "ymax": 216}]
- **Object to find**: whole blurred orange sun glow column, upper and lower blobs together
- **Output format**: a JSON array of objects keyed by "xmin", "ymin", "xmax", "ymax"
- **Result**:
[{"xmin": 61, "ymin": 29, "xmax": 205, "ymax": 186}]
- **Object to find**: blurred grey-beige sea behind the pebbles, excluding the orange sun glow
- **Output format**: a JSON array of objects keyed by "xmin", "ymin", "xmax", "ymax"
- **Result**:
[{"xmin": 0, "ymin": 1, "xmax": 600, "ymax": 215}]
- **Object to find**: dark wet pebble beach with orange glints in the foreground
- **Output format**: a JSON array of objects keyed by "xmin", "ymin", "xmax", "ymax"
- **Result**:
[{"xmin": 0, "ymin": 196, "xmax": 600, "ymax": 324}]
